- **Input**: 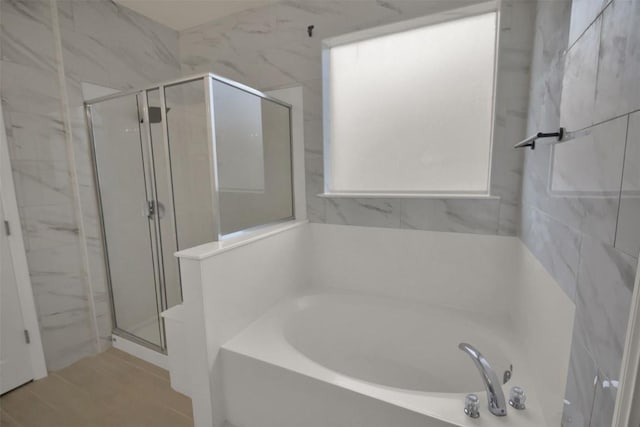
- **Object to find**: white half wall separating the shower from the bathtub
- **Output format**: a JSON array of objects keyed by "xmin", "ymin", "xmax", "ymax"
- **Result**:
[{"xmin": 176, "ymin": 221, "xmax": 309, "ymax": 427}]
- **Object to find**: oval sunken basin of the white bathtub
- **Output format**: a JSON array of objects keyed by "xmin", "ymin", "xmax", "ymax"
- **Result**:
[{"xmin": 283, "ymin": 295, "xmax": 511, "ymax": 393}]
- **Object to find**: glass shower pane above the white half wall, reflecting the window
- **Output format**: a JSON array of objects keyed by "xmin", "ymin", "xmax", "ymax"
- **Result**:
[{"xmin": 213, "ymin": 79, "xmax": 293, "ymax": 234}]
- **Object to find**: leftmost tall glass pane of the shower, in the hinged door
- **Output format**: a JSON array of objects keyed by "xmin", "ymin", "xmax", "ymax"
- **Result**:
[{"xmin": 90, "ymin": 94, "xmax": 162, "ymax": 347}]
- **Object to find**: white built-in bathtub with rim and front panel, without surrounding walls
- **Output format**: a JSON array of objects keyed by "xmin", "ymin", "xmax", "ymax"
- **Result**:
[{"xmin": 222, "ymin": 294, "xmax": 546, "ymax": 427}]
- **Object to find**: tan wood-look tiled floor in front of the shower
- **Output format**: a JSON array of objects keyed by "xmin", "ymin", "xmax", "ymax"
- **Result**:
[{"xmin": 0, "ymin": 349, "xmax": 193, "ymax": 427}]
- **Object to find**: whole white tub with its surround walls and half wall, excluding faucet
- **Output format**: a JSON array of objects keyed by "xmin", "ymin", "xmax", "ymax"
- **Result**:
[{"xmin": 178, "ymin": 223, "xmax": 574, "ymax": 427}]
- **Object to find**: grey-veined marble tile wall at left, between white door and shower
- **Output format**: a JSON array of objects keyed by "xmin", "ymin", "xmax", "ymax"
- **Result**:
[{"xmin": 0, "ymin": 0, "xmax": 180, "ymax": 370}]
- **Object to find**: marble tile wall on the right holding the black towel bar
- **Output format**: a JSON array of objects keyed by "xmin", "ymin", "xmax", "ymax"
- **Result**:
[{"xmin": 520, "ymin": 0, "xmax": 640, "ymax": 427}]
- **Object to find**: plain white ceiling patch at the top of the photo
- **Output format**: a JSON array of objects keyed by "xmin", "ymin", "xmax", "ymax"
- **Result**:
[{"xmin": 114, "ymin": 0, "xmax": 279, "ymax": 31}]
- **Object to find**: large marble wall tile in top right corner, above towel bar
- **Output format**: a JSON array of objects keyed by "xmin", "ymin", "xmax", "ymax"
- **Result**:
[{"xmin": 594, "ymin": 0, "xmax": 640, "ymax": 122}]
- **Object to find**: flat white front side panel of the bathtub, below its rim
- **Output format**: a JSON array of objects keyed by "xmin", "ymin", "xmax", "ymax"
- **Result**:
[{"xmin": 222, "ymin": 350, "xmax": 454, "ymax": 427}]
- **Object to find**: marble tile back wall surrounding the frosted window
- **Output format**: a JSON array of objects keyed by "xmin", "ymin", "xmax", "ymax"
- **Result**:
[{"xmin": 180, "ymin": 0, "xmax": 535, "ymax": 235}]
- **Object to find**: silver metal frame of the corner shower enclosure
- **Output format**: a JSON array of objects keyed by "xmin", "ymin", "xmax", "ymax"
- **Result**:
[{"xmin": 84, "ymin": 73, "xmax": 295, "ymax": 354}]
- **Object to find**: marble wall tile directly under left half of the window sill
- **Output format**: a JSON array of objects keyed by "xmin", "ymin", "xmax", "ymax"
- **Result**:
[{"xmin": 325, "ymin": 199, "xmax": 400, "ymax": 228}]
